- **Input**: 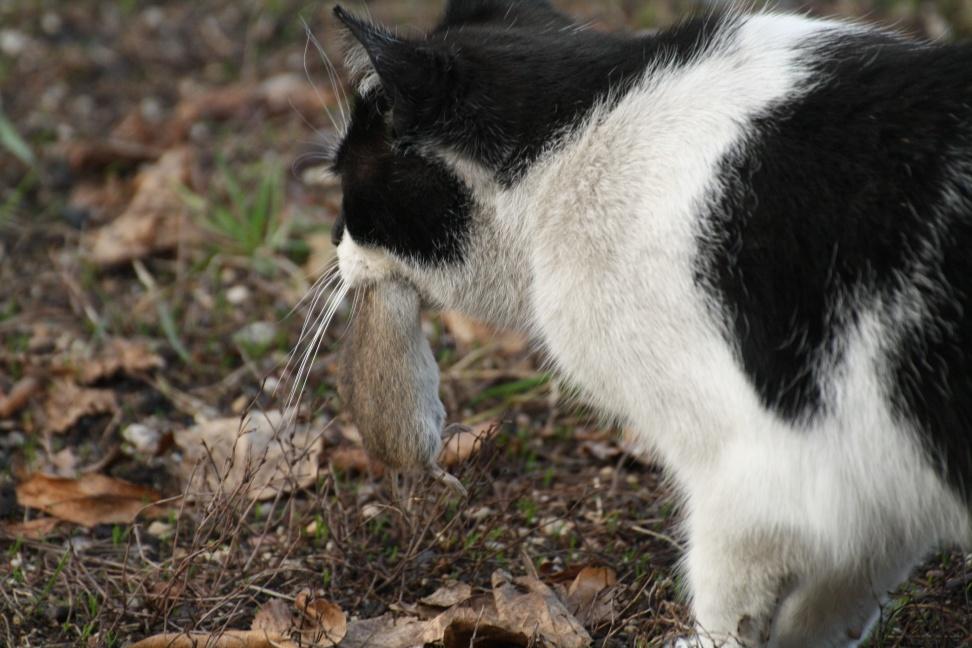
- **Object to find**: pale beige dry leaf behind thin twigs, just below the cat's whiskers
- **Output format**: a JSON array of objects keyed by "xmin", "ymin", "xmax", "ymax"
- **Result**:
[{"xmin": 174, "ymin": 410, "xmax": 324, "ymax": 500}]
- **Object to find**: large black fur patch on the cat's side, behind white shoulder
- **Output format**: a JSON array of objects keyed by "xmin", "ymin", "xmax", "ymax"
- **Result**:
[{"xmin": 699, "ymin": 35, "xmax": 972, "ymax": 502}]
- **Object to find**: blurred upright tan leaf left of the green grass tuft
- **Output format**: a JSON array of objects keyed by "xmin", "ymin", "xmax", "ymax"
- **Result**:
[{"xmin": 83, "ymin": 148, "xmax": 198, "ymax": 266}]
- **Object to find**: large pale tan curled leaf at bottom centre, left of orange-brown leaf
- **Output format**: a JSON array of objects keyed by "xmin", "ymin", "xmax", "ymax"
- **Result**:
[{"xmin": 492, "ymin": 569, "xmax": 591, "ymax": 648}]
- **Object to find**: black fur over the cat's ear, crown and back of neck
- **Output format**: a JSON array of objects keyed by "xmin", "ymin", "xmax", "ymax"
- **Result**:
[{"xmin": 337, "ymin": 5, "xmax": 735, "ymax": 185}]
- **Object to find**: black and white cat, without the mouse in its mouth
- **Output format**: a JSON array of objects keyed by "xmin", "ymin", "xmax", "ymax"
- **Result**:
[{"xmin": 322, "ymin": 0, "xmax": 972, "ymax": 646}]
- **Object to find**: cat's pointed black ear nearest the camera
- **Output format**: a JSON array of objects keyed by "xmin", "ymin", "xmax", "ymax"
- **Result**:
[{"xmin": 334, "ymin": 6, "xmax": 455, "ymax": 132}]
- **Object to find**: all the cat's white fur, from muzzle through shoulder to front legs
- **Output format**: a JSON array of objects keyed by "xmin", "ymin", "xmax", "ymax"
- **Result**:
[{"xmin": 338, "ymin": 15, "xmax": 972, "ymax": 646}]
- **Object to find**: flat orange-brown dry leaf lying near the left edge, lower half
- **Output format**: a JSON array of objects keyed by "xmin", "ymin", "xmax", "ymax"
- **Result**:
[{"xmin": 17, "ymin": 473, "xmax": 162, "ymax": 527}]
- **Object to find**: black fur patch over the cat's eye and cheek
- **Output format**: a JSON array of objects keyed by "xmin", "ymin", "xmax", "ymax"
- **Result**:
[{"xmin": 334, "ymin": 96, "xmax": 471, "ymax": 265}]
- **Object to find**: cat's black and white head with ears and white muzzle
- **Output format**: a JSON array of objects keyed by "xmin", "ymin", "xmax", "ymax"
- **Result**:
[{"xmin": 332, "ymin": 0, "xmax": 606, "ymax": 318}]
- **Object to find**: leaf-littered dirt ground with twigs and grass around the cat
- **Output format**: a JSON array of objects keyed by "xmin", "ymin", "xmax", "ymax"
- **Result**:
[{"xmin": 0, "ymin": 0, "xmax": 972, "ymax": 647}]
